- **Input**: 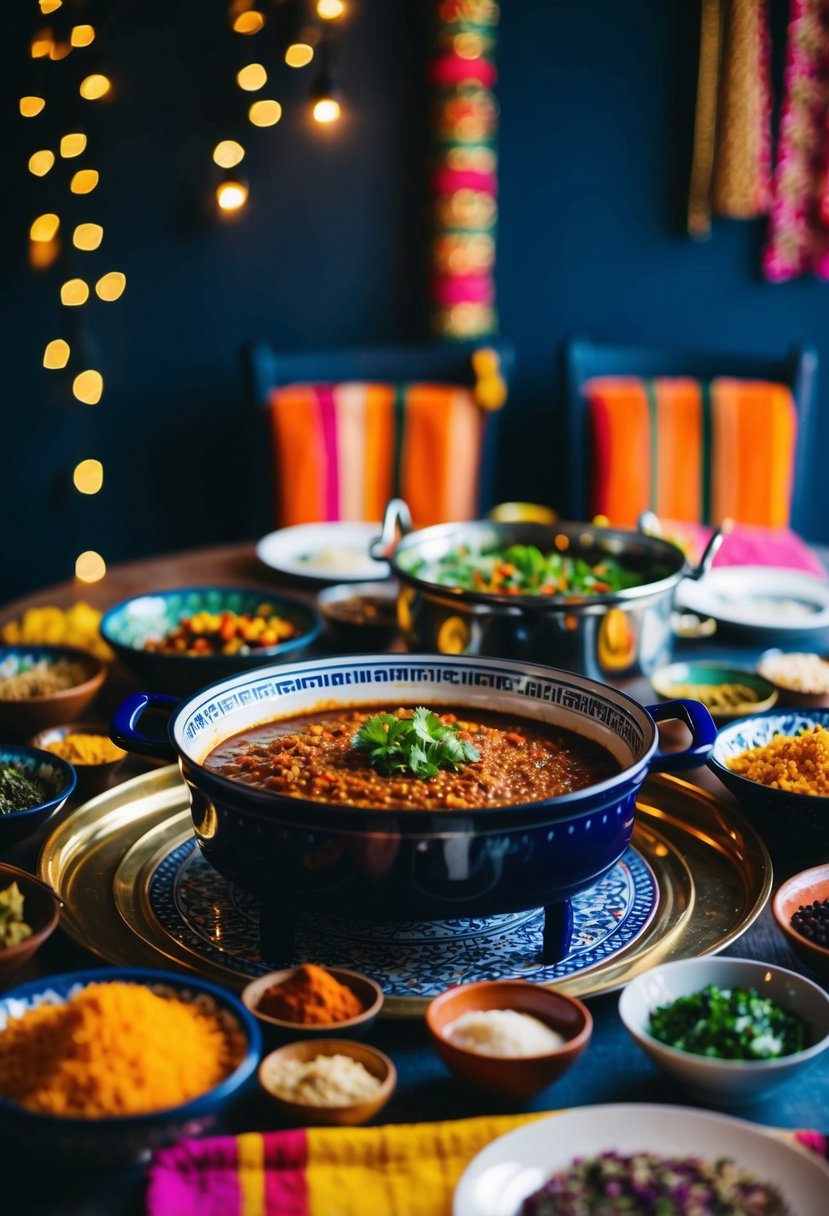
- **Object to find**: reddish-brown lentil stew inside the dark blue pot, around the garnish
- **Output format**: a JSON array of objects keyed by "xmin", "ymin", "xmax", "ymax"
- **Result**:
[{"xmin": 204, "ymin": 705, "xmax": 621, "ymax": 810}]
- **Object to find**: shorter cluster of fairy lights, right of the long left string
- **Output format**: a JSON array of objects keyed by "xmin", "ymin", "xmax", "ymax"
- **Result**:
[{"xmin": 213, "ymin": 0, "xmax": 346, "ymax": 215}]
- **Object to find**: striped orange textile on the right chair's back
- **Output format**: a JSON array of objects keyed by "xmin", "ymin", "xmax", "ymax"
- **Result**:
[{"xmin": 585, "ymin": 376, "xmax": 797, "ymax": 528}]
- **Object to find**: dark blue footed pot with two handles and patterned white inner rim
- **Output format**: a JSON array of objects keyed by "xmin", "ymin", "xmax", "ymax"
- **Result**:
[{"xmin": 112, "ymin": 654, "xmax": 717, "ymax": 958}]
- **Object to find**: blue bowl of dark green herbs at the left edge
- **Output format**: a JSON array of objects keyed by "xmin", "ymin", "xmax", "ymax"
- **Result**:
[{"xmin": 0, "ymin": 743, "xmax": 78, "ymax": 849}]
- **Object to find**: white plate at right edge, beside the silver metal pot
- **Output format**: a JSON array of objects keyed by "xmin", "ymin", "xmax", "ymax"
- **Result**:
[{"xmin": 677, "ymin": 565, "xmax": 829, "ymax": 634}]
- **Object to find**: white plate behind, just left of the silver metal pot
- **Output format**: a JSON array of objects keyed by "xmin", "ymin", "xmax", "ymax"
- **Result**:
[{"xmin": 256, "ymin": 522, "xmax": 391, "ymax": 582}]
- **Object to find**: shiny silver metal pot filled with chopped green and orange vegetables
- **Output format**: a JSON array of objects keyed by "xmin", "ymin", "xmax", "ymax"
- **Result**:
[{"xmin": 372, "ymin": 500, "xmax": 714, "ymax": 680}]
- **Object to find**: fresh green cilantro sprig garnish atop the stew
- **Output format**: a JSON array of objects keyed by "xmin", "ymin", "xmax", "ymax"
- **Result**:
[{"xmin": 351, "ymin": 705, "xmax": 480, "ymax": 778}]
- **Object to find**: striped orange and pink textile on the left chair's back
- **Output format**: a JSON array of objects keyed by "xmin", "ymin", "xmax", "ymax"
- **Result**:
[{"xmin": 270, "ymin": 383, "xmax": 490, "ymax": 527}]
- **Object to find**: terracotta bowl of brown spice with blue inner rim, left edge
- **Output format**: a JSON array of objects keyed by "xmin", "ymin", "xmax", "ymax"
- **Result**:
[{"xmin": 0, "ymin": 644, "xmax": 107, "ymax": 739}]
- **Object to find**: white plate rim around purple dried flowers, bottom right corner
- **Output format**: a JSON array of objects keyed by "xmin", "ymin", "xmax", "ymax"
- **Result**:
[{"xmin": 452, "ymin": 1104, "xmax": 829, "ymax": 1216}]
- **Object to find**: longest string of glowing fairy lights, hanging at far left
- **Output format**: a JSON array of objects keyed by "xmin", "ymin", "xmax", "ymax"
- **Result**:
[{"xmin": 19, "ymin": 0, "xmax": 126, "ymax": 582}]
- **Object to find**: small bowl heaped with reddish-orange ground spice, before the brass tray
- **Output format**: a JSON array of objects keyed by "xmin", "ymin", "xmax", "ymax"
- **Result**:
[{"xmin": 242, "ymin": 963, "xmax": 383, "ymax": 1038}]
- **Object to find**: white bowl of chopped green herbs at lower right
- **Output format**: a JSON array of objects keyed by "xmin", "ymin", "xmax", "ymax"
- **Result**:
[{"xmin": 619, "ymin": 956, "xmax": 829, "ymax": 1107}]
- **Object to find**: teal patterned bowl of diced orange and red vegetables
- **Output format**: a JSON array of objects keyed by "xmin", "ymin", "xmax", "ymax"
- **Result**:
[{"xmin": 101, "ymin": 587, "xmax": 322, "ymax": 694}]
